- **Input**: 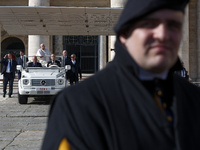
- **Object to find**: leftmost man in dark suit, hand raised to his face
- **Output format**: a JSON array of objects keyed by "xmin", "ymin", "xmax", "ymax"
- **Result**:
[{"xmin": 1, "ymin": 53, "xmax": 17, "ymax": 97}]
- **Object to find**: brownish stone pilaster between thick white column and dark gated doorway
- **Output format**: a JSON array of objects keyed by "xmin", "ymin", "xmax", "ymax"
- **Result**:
[{"xmin": 54, "ymin": 35, "xmax": 63, "ymax": 55}]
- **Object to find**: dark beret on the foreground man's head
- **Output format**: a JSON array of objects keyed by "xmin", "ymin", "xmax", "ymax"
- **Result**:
[{"xmin": 114, "ymin": 0, "xmax": 189, "ymax": 35}]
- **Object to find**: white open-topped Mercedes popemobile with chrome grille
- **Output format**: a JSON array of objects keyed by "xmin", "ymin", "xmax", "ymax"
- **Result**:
[{"xmin": 17, "ymin": 56, "xmax": 71, "ymax": 104}]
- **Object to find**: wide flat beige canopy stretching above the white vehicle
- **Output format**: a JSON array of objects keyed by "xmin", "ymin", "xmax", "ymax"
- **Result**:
[{"xmin": 0, "ymin": 6, "xmax": 123, "ymax": 35}]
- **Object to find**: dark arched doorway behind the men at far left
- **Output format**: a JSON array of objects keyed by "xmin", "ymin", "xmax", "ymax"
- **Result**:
[{"xmin": 1, "ymin": 37, "xmax": 25, "ymax": 57}]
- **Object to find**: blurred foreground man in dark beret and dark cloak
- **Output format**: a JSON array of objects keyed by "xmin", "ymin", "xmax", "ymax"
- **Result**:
[{"xmin": 43, "ymin": 0, "xmax": 200, "ymax": 150}]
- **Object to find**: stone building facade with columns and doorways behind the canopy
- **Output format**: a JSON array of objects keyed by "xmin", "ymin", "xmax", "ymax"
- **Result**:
[{"xmin": 0, "ymin": 0, "xmax": 200, "ymax": 82}]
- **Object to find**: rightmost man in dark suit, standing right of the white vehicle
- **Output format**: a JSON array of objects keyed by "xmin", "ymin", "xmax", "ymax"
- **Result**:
[{"xmin": 69, "ymin": 54, "xmax": 82, "ymax": 85}]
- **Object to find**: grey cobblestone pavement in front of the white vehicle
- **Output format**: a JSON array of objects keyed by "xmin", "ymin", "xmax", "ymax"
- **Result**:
[{"xmin": 0, "ymin": 91, "xmax": 50, "ymax": 150}]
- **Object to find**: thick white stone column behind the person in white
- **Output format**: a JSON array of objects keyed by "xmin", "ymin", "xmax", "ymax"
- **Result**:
[{"xmin": 28, "ymin": 0, "xmax": 52, "ymax": 56}]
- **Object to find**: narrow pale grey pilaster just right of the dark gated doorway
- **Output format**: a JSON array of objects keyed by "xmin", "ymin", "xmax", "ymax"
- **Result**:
[{"xmin": 98, "ymin": 35, "xmax": 106, "ymax": 70}]
